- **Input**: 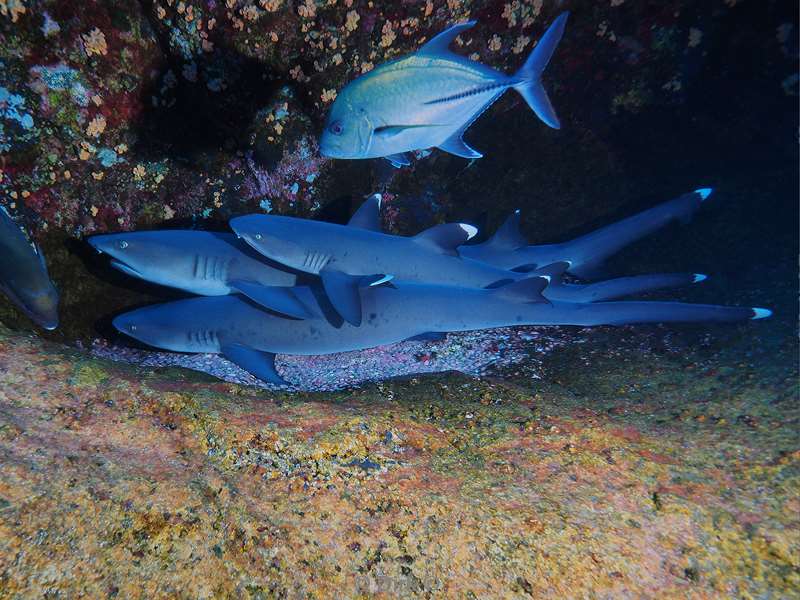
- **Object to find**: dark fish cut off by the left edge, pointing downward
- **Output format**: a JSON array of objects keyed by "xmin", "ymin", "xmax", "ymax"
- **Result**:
[{"xmin": 0, "ymin": 206, "xmax": 58, "ymax": 330}]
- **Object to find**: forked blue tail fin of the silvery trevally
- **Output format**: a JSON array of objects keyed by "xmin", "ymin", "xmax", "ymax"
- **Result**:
[{"xmin": 514, "ymin": 12, "xmax": 569, "ymax": 129}]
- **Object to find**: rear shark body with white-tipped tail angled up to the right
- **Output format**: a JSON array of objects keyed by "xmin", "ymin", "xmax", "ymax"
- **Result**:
[{"xmin": 458, "ymin": 188, "xmax": 713, "ymax": 279}]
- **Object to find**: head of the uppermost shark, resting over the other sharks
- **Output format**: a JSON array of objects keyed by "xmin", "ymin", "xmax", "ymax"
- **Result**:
[{"xmin": 229, "ymin": 215, "xmax": 316, "ymax": 272}]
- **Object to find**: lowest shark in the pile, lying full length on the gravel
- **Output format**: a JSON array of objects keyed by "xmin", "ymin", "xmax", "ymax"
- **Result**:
[{"xmin": 113, "ymin": 276, "xmax": 771, "ymax": 385}]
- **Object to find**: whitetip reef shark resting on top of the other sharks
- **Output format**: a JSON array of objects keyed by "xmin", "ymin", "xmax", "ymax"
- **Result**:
[{"xmin": 230, "ymin": 209, "xmax": 544, "ymax": 325}]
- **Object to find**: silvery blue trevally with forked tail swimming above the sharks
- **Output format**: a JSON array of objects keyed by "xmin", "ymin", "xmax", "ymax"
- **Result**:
[{"xmin": 320, "ymin": 12, "xmax": 569, "ymax": 166}]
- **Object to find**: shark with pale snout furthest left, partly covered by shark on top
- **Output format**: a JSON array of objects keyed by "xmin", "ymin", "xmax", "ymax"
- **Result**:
[{"xmin": 87, "ymin": 230, "xmax": 308, "ymax": 318}]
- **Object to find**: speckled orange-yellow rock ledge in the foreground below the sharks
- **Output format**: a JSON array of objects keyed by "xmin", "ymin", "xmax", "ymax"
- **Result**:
[{"xmin": 0, "ymin": 323, "xmax": 800, "ymax": 598}]
